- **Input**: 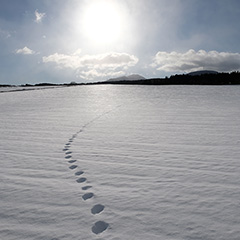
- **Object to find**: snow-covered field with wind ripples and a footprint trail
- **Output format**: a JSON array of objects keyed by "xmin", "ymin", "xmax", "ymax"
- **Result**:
[{"xmin": 0, "ymin": 85, "xmax": 240, "ymax": 240}]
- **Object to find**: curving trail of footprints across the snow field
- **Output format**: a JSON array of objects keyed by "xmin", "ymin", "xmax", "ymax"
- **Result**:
[{"xmin": 63, "ymin": 108, "xmax": 120, "ymax": 234}]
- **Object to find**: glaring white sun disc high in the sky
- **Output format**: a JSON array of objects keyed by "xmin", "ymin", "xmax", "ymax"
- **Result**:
[{"xmin": 82, "ymin": 0, "xmax": 124, "ymax": 44}]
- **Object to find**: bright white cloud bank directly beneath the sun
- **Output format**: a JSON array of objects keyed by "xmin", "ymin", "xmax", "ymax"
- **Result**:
[{"xmin": 42, "ymin": 50, "xmax": 138, "ymax": 80}]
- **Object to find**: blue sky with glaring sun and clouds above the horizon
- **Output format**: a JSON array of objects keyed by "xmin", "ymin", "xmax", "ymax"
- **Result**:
[{"xmin": 0, "ymin": 0, "xmax": 240, "ymax": 85}]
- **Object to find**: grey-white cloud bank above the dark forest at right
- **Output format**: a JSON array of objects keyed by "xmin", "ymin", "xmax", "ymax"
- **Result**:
[{"xmin": 151, "ymin": 49, "xmax": 240, "ymax": 72}]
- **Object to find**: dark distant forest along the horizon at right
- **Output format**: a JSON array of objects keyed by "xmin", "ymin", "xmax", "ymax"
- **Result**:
[{"xmin": 104, "ymin": 72, "xmax": 240, "ymax": 85}]
